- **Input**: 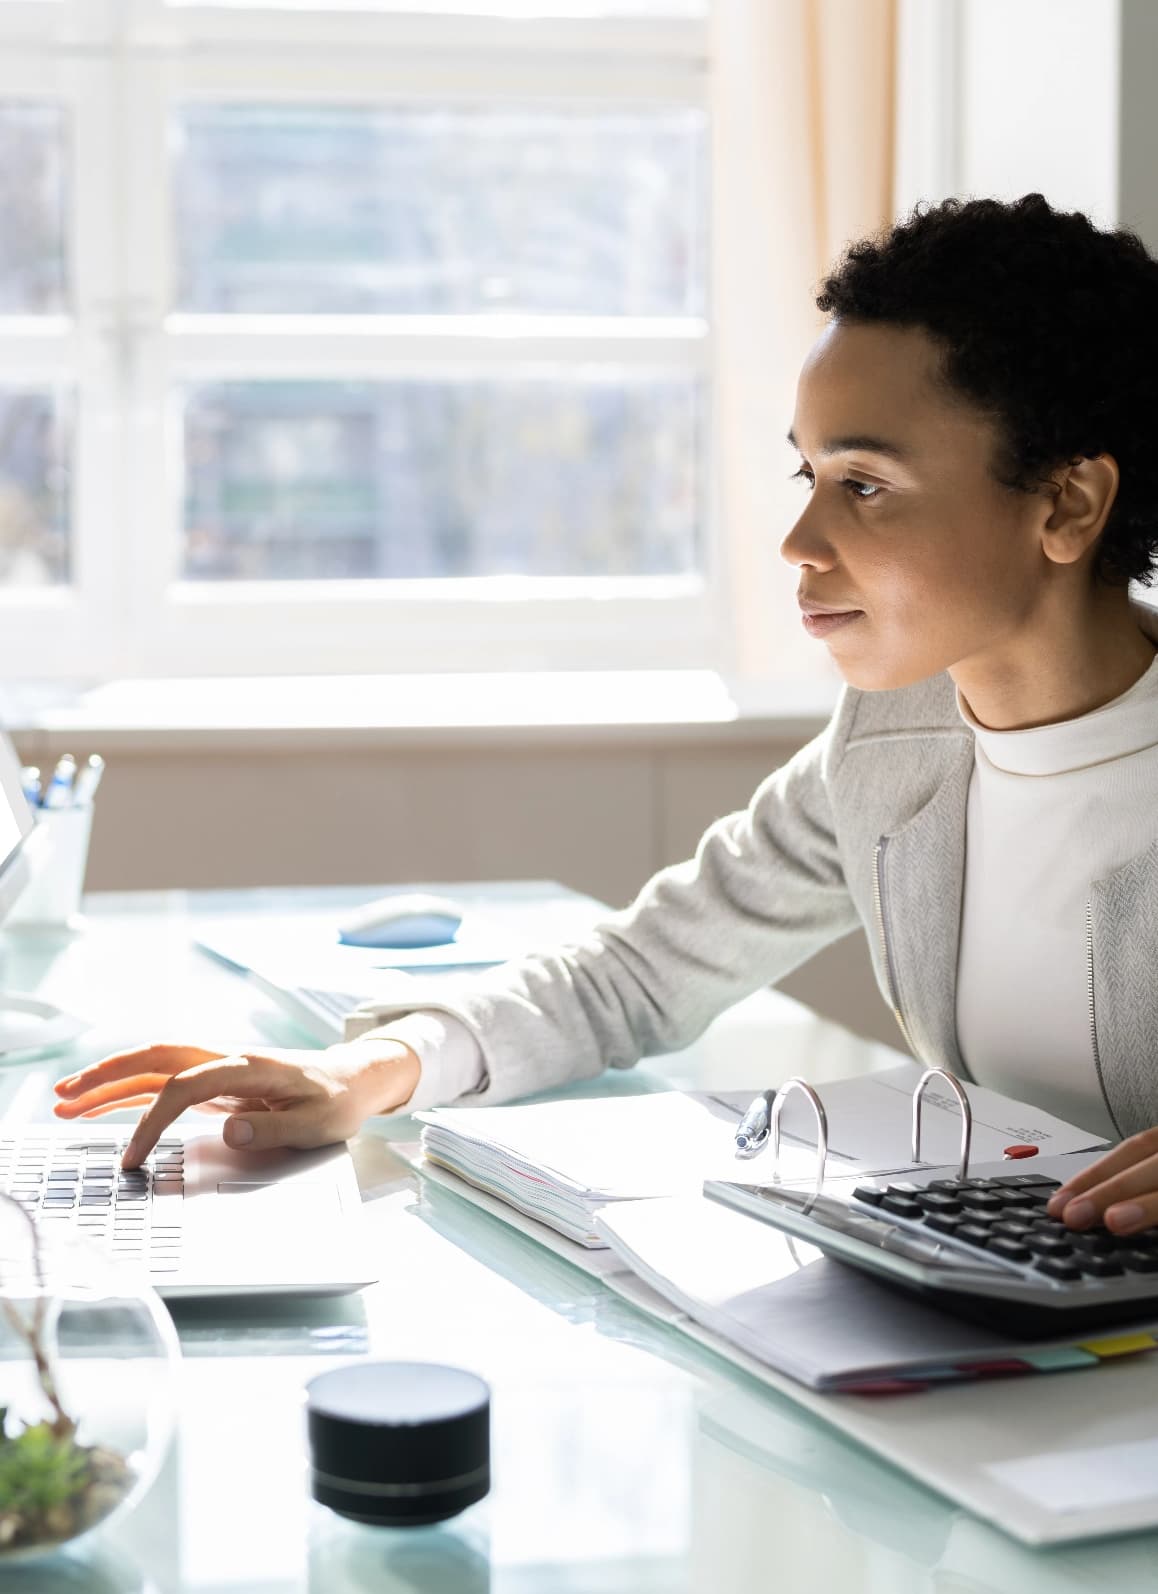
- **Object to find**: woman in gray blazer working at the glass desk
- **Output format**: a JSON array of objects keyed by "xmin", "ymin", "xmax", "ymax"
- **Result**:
[{"xmin": 56, "ymin": 194, "xmax": 1158, "ymax": 1234}]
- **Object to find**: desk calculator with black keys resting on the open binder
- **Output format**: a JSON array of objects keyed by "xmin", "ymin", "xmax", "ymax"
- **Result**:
[{"xmin": 703, "ymin": 1152, "xmax": 1158, "ymax": 1339}]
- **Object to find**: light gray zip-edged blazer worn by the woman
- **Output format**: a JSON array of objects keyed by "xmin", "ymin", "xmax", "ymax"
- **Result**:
[{"xmin": 346, "ymin": 612, "xmax": 1158, "ymax": 1135}]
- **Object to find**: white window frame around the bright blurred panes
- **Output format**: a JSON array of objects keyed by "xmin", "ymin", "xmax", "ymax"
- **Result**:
[{"xmin": 0, "ymin": 0, "xmax": 729, "ymax": 677}]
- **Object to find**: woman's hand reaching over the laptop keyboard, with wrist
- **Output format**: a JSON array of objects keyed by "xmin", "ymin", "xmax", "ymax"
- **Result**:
[{"xmin": 54, "ymin": 1036, "xmax": 419, "ymax": 1168}]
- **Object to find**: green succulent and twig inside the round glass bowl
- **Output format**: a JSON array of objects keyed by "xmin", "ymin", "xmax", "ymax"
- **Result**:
[{"xmin": 0, "ymin": 1194, "xmax": 132, "ymax": 1554}]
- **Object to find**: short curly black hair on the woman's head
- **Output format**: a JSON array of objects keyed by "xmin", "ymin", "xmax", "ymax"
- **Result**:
[{"xmin": 817, "ymin": 194, "xmax": 1158, "ymax": 585}]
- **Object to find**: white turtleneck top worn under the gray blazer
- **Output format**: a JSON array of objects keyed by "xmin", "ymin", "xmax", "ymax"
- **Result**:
[{"xmin": 957, "ymin": 658, "xmax": 1158, "ymax": 1140}]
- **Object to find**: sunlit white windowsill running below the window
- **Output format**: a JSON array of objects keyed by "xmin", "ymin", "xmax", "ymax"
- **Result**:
[{"xmin": 0, "ymin": 669, "xmax": 837, "ymax": 751}]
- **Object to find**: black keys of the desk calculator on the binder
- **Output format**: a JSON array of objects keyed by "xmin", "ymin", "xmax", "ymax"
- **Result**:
[{"xmin": 853, "ymin": 1173, "xmax": 1158, "ymax": 1283}]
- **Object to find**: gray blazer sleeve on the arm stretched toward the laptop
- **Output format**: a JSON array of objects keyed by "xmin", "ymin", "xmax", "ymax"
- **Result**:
[{"xmin": 346, "ymin": 693, "xmax": 860, "ymax": 1105}]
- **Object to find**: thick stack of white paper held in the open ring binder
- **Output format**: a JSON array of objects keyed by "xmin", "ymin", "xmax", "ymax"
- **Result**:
[{"xmin": 415, "ymin": 1063, "xmax": 1101, "ymax": 1247}]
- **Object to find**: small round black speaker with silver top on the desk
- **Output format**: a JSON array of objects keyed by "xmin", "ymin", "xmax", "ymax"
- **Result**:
[{"xmin": 306, "ymin": 1361, "xmax": 491, "ymax": 1527}]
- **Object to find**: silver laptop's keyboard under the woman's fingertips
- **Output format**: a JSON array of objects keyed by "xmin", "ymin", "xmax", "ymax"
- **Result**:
[{"xmin": 0, "ymin": 1132, "xmax": 185, "ymax": 1275}]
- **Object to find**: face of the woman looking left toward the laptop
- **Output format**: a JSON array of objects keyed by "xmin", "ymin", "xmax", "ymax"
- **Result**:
[{"xmin": 780, "ymin": 320, "xmax": 1051, "ymax": 690}]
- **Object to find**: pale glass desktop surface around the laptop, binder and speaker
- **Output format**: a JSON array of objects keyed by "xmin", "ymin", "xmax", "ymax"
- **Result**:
[{"xmin": 0, "ymin": 891, "xmax": 1158, "ymax": 1594}]
